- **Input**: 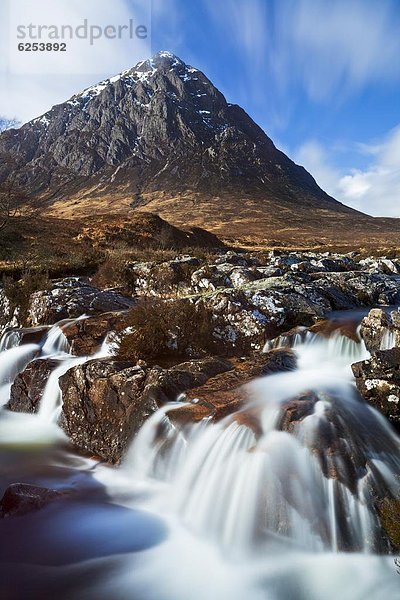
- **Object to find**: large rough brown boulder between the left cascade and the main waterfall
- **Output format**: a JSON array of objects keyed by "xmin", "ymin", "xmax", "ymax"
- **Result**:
[{"xmin": 60, "ymin": 358, "xmax": 231, "ymax": 462}]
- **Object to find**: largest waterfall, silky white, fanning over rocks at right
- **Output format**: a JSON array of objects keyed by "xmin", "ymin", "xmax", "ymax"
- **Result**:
[{"xmin": 123, "ymin": 333, "xmax": 400, "ymax": 553}]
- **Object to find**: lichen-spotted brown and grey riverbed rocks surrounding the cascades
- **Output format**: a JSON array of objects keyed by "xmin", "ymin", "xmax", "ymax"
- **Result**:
[{"xmin": 0, "ymin": 251, "xmax": 400, "ymax": 454}]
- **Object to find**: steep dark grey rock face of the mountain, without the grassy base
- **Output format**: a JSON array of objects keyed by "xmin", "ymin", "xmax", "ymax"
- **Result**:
[{"xmin": 0, "ymin": 52, "xmax": 346, "ymax": 214}]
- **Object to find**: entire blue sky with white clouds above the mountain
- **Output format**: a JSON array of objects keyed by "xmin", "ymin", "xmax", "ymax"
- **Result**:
[{"xmin": 0, "ymin": 0, "xmax": 400, "ymax": 216}]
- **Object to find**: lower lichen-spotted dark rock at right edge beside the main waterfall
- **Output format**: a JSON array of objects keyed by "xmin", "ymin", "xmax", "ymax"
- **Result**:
[{"xmin": 352, "ymin": 348, "xmax": 400, "ymax": 427}]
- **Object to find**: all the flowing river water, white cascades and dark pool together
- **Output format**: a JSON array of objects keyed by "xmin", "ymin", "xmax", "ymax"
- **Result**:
[{"xmin": 0, "ymin": 316, "xmax": 400, "ymax": 600}]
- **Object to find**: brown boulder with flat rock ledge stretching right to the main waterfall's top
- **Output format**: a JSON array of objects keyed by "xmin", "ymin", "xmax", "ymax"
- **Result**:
[{"xmin": 60, "ymin": 350, "xmax": 295, "ymax": 463}]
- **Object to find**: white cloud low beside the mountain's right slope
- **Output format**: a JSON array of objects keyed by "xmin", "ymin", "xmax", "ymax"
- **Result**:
[{"xmin": 295, "ymin": 125, "xmax": 400, "ymax": 217}]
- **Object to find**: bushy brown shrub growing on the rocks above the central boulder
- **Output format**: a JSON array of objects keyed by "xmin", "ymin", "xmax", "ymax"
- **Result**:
[{"xmin": 119, "ymin": 298, "xmax": 215, "ymax": 361}]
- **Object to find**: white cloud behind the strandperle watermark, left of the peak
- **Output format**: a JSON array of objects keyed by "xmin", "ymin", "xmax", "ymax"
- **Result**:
[{"xmin": 0, "ymin": 0, "xmax": 151, "ymax": 121}]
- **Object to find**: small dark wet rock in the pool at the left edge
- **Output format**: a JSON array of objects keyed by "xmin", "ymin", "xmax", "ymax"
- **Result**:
[{"xmin": 0, "ymin": 483, "xmax": 65, "ymax": 519}]
